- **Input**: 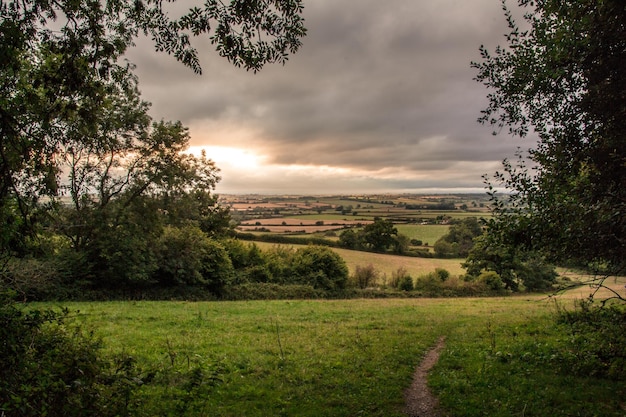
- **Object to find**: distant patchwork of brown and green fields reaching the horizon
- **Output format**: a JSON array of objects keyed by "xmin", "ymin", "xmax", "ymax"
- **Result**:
[{"xmin": 220, "ymin": 194, "xmax": 490, "ymax": 253}]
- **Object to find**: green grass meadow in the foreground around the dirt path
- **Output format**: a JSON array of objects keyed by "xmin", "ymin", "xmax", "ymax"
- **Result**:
[{"xmin": 41, "ymin": 296, "xmax": 626, "ymax": 416}]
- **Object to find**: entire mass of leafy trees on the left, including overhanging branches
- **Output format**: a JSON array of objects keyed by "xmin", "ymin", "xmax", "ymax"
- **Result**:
[{"xmin": 0, "ymin": 0, "xmax": 306, "ymax": 291}]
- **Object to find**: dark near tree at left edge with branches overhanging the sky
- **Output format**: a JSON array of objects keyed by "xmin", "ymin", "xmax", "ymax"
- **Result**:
[{"xmin": 0, "ymin": 0, "xmax": 305, "ymax": 253}]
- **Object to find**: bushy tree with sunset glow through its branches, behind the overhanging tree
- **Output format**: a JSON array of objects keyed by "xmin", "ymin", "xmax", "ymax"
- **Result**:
[{"xmin": 49, "ymin": 116, "xmax": 228, "ymax": 286}]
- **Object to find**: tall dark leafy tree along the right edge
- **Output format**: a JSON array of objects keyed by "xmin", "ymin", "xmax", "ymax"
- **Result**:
[{"xmin": 472, "ymin": 0, "xmax": 626, "ymax": 279}]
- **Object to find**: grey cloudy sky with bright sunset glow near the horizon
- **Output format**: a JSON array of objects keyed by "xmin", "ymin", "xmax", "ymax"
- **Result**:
[{"xmin": 129, "ymin": 0, "xmax": 528, "ymax": 194}]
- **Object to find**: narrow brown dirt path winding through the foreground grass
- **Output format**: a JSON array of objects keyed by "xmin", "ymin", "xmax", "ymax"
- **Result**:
[{"xmin": 404, "ymin": 337, "xmax": 445, "ymax": 417}]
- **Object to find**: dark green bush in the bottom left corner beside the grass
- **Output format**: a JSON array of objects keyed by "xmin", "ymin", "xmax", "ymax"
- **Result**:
[{"xmin": 0, "ymin": 293, "xmax": 141, "ymax": 416}]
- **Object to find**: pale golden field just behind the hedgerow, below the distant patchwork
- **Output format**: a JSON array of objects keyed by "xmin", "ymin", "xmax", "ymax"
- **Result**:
[{"xmin": 254, "ymin": 242, "xmax": 465, "ymax": 278}]
